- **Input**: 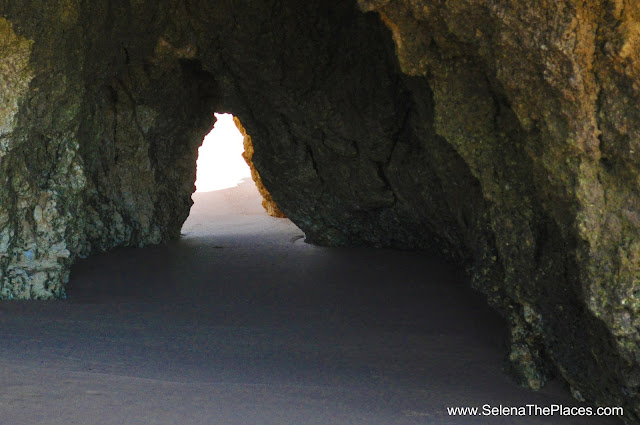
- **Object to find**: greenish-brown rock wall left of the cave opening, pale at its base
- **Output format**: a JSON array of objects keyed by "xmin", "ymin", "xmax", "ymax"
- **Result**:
[{"xmin": 0, "ymin": 0, "xmax": 214, "ymax": 298}]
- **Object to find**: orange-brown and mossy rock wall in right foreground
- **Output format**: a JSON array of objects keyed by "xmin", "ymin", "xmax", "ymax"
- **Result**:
[{"xmin": 360, "ymin": 0, "xmax": 640, "ymax": 417}]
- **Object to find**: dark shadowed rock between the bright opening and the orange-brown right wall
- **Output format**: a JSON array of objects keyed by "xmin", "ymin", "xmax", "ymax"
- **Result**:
[{"xmin": 196, "ymin": 1, "xmax": 488, "ymax": 252}]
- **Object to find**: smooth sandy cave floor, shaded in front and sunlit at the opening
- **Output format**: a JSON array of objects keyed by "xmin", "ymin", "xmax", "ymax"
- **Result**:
[{"xmin": 0, "ymin": 182, "xmax": 618, "ymax": 425}]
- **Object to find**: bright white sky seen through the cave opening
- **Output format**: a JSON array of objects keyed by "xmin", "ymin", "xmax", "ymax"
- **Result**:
[{"xmin": 196, "ymin": 114, "xmax": 251, "ymax": 192}]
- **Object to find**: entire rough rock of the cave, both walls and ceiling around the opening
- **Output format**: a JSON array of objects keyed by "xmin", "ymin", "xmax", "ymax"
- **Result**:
[{"xmin": 0, "ymin": 0, "xmax": 640, "ymax": 421}]
